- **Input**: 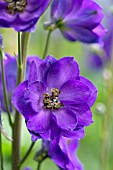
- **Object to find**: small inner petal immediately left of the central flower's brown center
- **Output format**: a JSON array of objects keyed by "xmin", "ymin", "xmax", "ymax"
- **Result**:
[{"xmin": 28, "ymin": 81, "xmax": 46, "ymax": 112}]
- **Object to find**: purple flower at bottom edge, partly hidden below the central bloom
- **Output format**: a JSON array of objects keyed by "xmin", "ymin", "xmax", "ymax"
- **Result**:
[{"xmin": 43, "ymin": 137, "xmax": 84, "ymax": 170}]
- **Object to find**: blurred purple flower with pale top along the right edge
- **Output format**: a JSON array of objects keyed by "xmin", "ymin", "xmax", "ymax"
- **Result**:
[{"xmin": 86, "ymin": 13, "xmax": 113, "ymax": 69}]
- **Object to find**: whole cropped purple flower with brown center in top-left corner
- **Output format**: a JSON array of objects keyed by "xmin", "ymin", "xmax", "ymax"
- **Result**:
[{"xmin": 0, "ymin": 0, "xmax": 50, "ymax": 32}]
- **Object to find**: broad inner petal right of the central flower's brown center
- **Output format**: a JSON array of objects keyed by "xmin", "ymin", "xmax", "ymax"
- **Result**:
[{"xmin": 59, "ymin": 80, "xmax": 91, "ymax": 103}]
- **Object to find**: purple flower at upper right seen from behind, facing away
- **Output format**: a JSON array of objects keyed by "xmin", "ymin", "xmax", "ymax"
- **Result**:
[{"xmin": 45, "ymin": 0, "xmax": 105, "ymax": 43}]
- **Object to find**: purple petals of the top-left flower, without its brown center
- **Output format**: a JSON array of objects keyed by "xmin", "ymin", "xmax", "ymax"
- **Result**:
[{"xmin": 0, "ymin": 0, "xmax": 50, "ymax": 32}]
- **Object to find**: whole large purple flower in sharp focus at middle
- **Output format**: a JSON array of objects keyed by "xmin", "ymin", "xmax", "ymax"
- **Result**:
[{"xmin": 12, "ymin": 56, "xmax": 97, "ymax": 141}]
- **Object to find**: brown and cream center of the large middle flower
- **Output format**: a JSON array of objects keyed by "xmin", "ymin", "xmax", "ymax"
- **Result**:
[{"xmin": 43, "ymin": 88, "xmax": 63, "ymax": 110}]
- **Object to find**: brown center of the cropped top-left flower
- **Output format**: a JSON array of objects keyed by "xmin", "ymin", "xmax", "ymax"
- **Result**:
[{"xmin": 4, "ymin": 0, "xmax": 27, "ymax": 15}]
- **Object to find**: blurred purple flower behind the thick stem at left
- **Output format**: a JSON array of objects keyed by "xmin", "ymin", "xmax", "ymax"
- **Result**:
[{"xmin": 0, "ymin": 53, "xmax": 37, "ymax": 111}]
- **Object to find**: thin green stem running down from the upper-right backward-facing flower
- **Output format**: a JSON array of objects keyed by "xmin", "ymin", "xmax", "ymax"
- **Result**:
[{"xmin": 42, "ymin": 30, "xmax": 52, "ymax": 60}]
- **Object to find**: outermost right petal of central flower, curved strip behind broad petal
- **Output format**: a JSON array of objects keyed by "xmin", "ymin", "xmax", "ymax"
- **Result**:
[{"xmin": 80, "ymin": 76, "xmax": 98, "ymax": 107}]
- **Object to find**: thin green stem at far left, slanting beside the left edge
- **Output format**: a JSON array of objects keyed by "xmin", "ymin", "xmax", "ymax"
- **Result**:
[{"xmin": 0, "ymin": 48, "xmax": 13, "ymax": 127}]
